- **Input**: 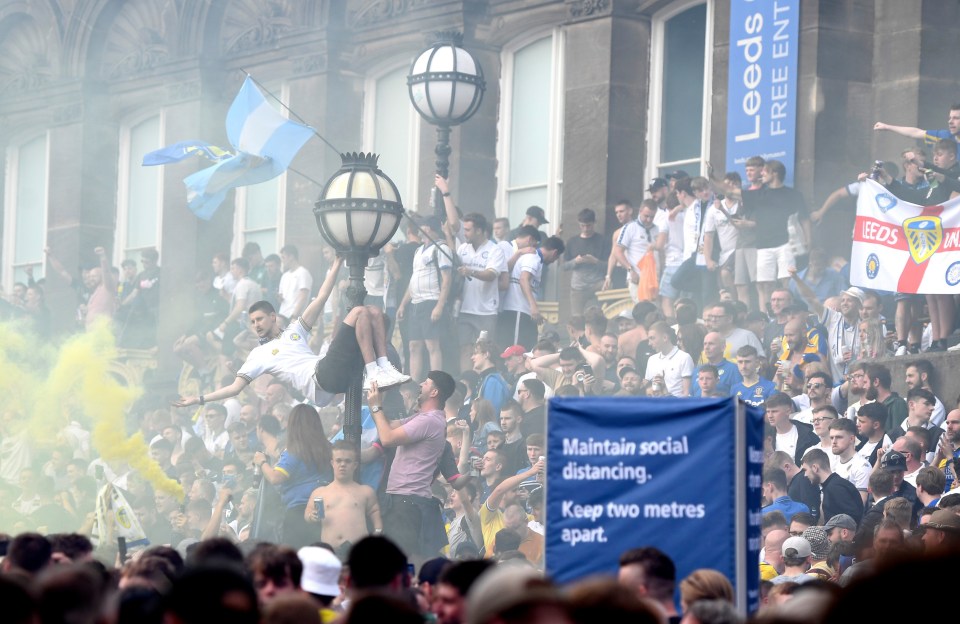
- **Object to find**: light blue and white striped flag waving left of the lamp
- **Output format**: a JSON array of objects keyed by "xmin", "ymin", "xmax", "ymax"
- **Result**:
[{"xmin": 183, "ymin": 76, "xmax": 313, "ymax": 220}]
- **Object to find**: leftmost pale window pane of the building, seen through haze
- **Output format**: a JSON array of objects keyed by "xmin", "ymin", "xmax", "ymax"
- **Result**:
[{"xmin": 13, "ymin": 136, "xmax": 47, "ymax": 270}]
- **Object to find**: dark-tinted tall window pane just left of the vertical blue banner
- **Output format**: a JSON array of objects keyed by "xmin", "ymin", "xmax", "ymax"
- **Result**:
[{"xmin": 660, "ymin": 4, "xmax": 707, "ymax": 162}]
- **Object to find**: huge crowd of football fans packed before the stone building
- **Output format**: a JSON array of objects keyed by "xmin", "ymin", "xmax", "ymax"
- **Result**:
[{"xmin": 0, "ymin": 106, "xmax": 960, "ymax": 622}]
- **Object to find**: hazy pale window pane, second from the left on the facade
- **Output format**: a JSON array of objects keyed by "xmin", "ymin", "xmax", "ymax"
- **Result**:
[{"xmin": 126, "ymin": 116, "xmax": 161, "ymax": 256}]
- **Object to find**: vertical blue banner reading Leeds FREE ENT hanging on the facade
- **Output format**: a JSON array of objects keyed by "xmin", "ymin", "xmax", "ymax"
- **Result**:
[{"xmin": 727, "ymin": 0, "xmax": 800, "ymax": 185}]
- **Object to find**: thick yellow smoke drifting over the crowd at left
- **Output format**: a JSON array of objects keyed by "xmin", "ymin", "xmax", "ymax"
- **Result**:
[{"xmin": 0, "ymin": 323, "xmax": 183, "ymax": 500}]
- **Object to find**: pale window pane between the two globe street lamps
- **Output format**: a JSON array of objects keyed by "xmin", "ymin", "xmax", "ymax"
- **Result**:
[{"xmin": 373, "ymin": 67, "xmax": 416, "ymax": 205}]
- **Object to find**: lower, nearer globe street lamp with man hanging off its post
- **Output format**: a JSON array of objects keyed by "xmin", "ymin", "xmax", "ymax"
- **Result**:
[{"xmin": 313, "ymin": 153, "xmax": 403, "ymax": 456}]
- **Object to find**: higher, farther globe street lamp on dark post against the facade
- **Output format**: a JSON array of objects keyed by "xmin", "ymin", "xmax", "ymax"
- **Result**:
[{"xmin": 407, "ymin": 32, "xmax": 486, "ymax": 219}]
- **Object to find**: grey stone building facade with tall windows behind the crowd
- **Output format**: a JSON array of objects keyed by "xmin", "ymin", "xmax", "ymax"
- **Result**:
[{"xmin": 0, "ymin": 0, "xmax": 960, "ymax": 380}]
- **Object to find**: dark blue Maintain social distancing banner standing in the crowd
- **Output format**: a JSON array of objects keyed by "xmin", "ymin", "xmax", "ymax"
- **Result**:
[{"xmin": 546, "ymin": 397, "xmax": 763, "ymax": 612}]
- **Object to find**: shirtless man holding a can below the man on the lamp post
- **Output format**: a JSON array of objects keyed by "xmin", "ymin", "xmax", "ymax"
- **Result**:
[{"xmin": 303, "ymin": 440, "xmax": 383, "ymax": 554}]
